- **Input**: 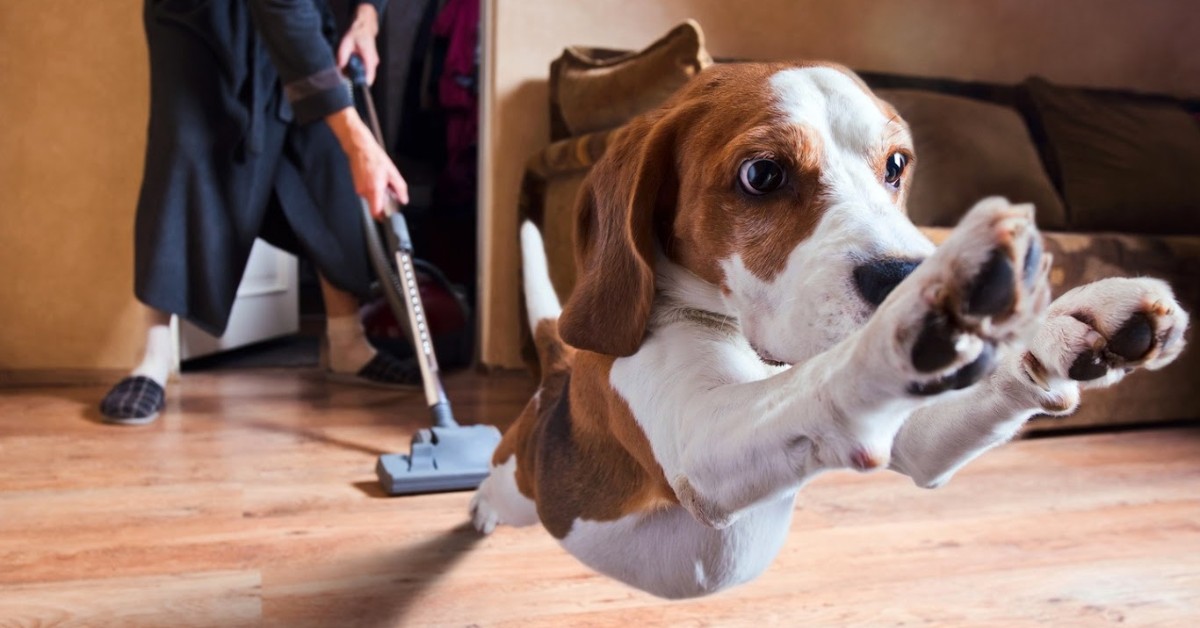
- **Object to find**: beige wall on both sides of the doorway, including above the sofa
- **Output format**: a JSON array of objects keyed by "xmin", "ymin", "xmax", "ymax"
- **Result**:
[{"xmin": 7, "ymin": 0, "xmax": 1200, "ymax": 371}]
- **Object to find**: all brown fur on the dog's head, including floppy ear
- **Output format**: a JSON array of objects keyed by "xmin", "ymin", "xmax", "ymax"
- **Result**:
[{"xmin": 560, "ymin": 64, "xmax": 910, "ymax": 355}]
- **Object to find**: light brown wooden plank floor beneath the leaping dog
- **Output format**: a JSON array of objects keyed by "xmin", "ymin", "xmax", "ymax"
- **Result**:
[{"xmin": 0, "ymin": 369, "xmax": 1200, "ymax": 627}]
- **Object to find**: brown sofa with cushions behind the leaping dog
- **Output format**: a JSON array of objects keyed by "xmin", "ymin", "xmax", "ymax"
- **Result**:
[{"xmin": 520, "ymin": 22, "xmax": 1200, "ymax": 430}]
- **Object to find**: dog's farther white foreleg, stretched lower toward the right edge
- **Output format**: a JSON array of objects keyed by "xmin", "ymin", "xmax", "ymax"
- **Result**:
[{"xmin": 890, "ymin": 279, "xmax": 1188, "ymax": 488}]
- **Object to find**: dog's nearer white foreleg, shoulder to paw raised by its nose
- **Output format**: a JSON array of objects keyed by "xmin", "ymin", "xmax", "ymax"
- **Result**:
[{"xmin": 638, "ymin": 199, "xmax": 1049, "ymax": 527}]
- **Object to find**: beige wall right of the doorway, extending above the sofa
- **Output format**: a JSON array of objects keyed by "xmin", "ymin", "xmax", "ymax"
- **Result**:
[{"xmin": 481, "ymin": 0, "xmax": 1200, "ymax": 366}]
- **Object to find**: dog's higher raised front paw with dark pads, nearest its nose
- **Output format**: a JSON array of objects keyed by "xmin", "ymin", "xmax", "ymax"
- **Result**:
[{"xmin": 889, "ymin": 198, "xmax": 1050, "ymax": 395}]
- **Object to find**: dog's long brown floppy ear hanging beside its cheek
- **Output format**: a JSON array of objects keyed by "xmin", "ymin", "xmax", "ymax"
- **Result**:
[{"xmin": 558, "ymin": 114, "xmax": 678, "ymax": 355}]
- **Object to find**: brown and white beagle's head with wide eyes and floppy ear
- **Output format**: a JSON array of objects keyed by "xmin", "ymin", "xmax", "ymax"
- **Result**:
[{"xmin": 559, "ymin": 64, "xmax": 932, "ymax": 363}]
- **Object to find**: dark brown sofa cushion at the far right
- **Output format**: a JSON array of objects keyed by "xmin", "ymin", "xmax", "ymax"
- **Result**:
[{"xmin": 1020, "ymin": 78, "xmax": 1200, "ymax": 234}]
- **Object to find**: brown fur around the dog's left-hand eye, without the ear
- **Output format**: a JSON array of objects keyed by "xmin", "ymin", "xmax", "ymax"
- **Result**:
[{"xmin": 667, "ymin": 64, "xmax": 824, "ymax": 285}]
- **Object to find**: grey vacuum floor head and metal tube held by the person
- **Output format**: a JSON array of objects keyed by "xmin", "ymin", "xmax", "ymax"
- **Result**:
[{"xmin": 347, "ymin": 55, "xmax": 500, "ymax": 495}]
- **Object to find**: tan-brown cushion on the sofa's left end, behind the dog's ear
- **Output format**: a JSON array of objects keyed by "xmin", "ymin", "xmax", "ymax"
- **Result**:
[{"xmin": 550, "ymin": 19, "xmax": 713, "ymax": 139}]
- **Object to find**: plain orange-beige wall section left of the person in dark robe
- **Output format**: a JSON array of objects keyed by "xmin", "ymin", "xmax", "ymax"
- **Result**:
[{"xmin": 0, "ymin": 0, "xmax": 149, "ymax": 371}]
